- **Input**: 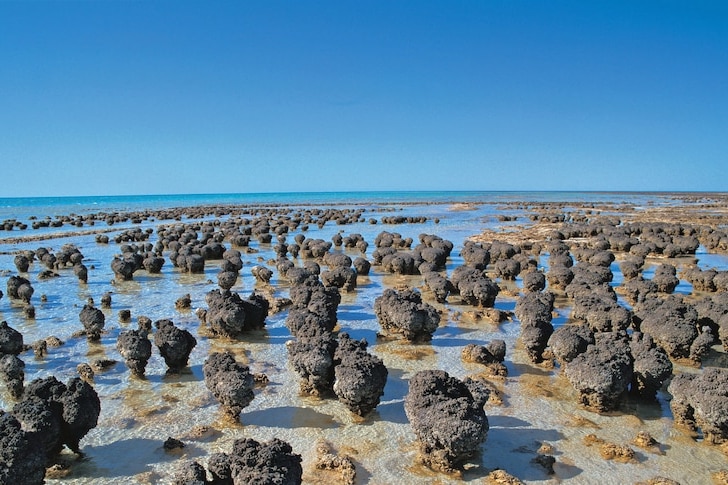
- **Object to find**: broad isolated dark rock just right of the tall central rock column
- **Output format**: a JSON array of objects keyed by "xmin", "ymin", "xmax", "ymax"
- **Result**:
[{"xmin": 374, "ymin": 288, "xmax": 440, "ymax": 341}]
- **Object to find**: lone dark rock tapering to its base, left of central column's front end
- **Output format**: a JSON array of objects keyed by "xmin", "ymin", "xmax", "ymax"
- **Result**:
[{"xmin": 202, "ymin": 352, "xmax": 255, "ymax": 420}]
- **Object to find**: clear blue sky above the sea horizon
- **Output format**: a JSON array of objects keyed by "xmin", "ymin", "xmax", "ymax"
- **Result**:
[{"xmin": 0, "ymin": 0, "xmax": 728, "ymax": 197}]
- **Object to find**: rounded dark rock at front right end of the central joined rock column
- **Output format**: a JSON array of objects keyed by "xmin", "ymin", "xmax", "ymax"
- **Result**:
[{"xmin": 333, "ymin": 333, "xmax": 388, "ymax": 416}]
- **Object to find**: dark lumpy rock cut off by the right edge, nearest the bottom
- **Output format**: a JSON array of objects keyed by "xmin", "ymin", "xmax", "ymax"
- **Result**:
[{"xmin": 667, "ymin": 367, "xmax": 728, "ymax": 444}]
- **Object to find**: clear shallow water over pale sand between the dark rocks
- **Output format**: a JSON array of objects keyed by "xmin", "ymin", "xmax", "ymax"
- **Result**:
[{"xmin": 0, "ymin": 194, "xmax": 728, "ymax": 484}]
